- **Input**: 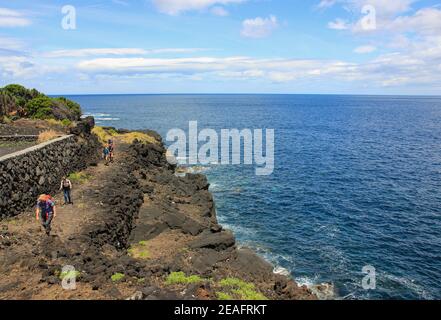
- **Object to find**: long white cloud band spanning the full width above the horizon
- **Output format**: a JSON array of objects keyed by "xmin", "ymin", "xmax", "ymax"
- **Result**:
[{"xmin": 0, "ymin": 45, "xmax": 441, "ymax": 88}]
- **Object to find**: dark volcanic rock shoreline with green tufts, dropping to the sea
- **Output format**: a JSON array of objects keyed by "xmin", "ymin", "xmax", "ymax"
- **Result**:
[{"xmin": 0, "ymin": 124, "xmax": 316, "ymax": 300}]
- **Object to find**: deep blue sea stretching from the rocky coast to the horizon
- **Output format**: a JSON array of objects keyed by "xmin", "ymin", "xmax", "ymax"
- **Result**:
[{"xmin": 65, "ymin": 95, "xmax": 441, "ymax": 299}]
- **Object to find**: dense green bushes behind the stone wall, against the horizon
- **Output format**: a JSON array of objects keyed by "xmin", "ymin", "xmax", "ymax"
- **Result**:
[{"xmin": 0, "ymin": 84, "xmax": 81, "ymax": 121}]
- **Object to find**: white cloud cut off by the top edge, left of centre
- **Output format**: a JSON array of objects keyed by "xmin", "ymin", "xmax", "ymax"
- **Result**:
[{"xmin": 153, "ymin": 0, "xmax": 241, "ymax": 15}]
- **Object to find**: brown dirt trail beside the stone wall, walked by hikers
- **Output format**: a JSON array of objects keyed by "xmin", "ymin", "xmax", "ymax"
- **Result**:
[{"xmin": 0, "ymin": 140, "xmax": 127, "ymax": 299}]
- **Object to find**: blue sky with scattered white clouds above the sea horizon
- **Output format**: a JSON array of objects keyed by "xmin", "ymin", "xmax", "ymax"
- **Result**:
[{"xmin": 0, "ymin": 0, "xmax": 441, "ymax": 94}]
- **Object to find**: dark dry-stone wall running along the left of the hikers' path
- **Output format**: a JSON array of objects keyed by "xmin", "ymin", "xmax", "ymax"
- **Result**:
[{"xmin": 0, "ymin": 135, "xmax": 100, "ymax": 219}]
